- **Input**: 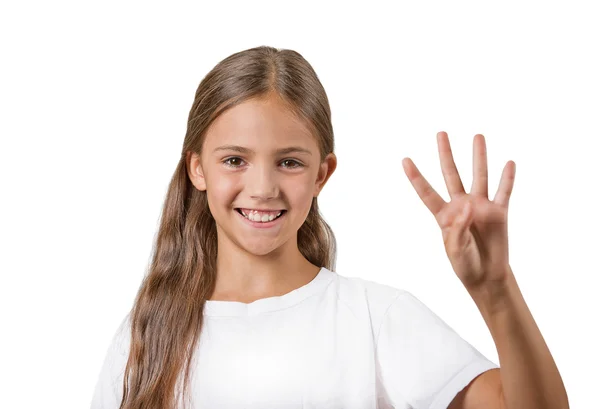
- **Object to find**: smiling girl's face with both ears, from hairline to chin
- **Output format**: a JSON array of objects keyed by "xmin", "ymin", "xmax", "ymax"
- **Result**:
[{"xmin": 188, "ymin": 97, "xmax": 336, "ymax": 255}]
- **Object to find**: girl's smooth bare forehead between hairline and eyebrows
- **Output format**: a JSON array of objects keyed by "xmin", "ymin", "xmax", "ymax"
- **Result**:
[{"xmin": 204, "ymin": 98, "xmax": 316, "ymax": 150}]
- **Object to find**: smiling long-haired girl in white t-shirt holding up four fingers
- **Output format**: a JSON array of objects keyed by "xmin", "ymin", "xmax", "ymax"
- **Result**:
[{"xmin": 92, "ymin": 47, "xmax": 568, "ymax": 409}]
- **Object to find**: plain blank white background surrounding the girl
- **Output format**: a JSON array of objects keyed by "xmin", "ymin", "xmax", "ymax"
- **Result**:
[{"xmin": 0, "ymin": 1, "xmax": 600, "ymax": 409}]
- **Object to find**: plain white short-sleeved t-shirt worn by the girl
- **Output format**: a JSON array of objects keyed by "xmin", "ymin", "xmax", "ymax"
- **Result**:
[{"xmin": 91, "ymin": 268, "xmax": 498, "ymax": 409}]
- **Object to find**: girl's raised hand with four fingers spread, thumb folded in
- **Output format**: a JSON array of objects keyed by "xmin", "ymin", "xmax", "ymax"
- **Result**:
[{"xmin": 402, "ymin": 132, "xmax": 515, "ymax": 288}]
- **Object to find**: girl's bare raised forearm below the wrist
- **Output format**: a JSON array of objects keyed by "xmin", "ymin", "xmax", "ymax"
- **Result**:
[{"xmin": 470, "ymin": 267, "xmax": 569, "ymax": 409}]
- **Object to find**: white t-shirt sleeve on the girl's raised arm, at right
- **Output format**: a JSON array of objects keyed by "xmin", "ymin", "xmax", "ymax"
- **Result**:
[{"xmin": 376, "ymin": 291, "xmax": 499, "ymax": 409}]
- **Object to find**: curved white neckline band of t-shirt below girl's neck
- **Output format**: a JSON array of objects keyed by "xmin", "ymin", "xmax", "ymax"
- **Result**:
[{"xmin": 204, "ymin": 267, "xmax": 334, "ymax": 317}]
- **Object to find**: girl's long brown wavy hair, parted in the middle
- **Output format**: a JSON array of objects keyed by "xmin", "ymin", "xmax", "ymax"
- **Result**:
[{"xmin": 120, "ymin": 46, "xmax": 336, "ymax": 409}]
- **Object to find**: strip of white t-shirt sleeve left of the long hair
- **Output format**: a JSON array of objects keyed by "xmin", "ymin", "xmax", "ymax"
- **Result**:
[{"xmin": 91, "ymin": 314, "xmax": 131, "ymax": 409}]
